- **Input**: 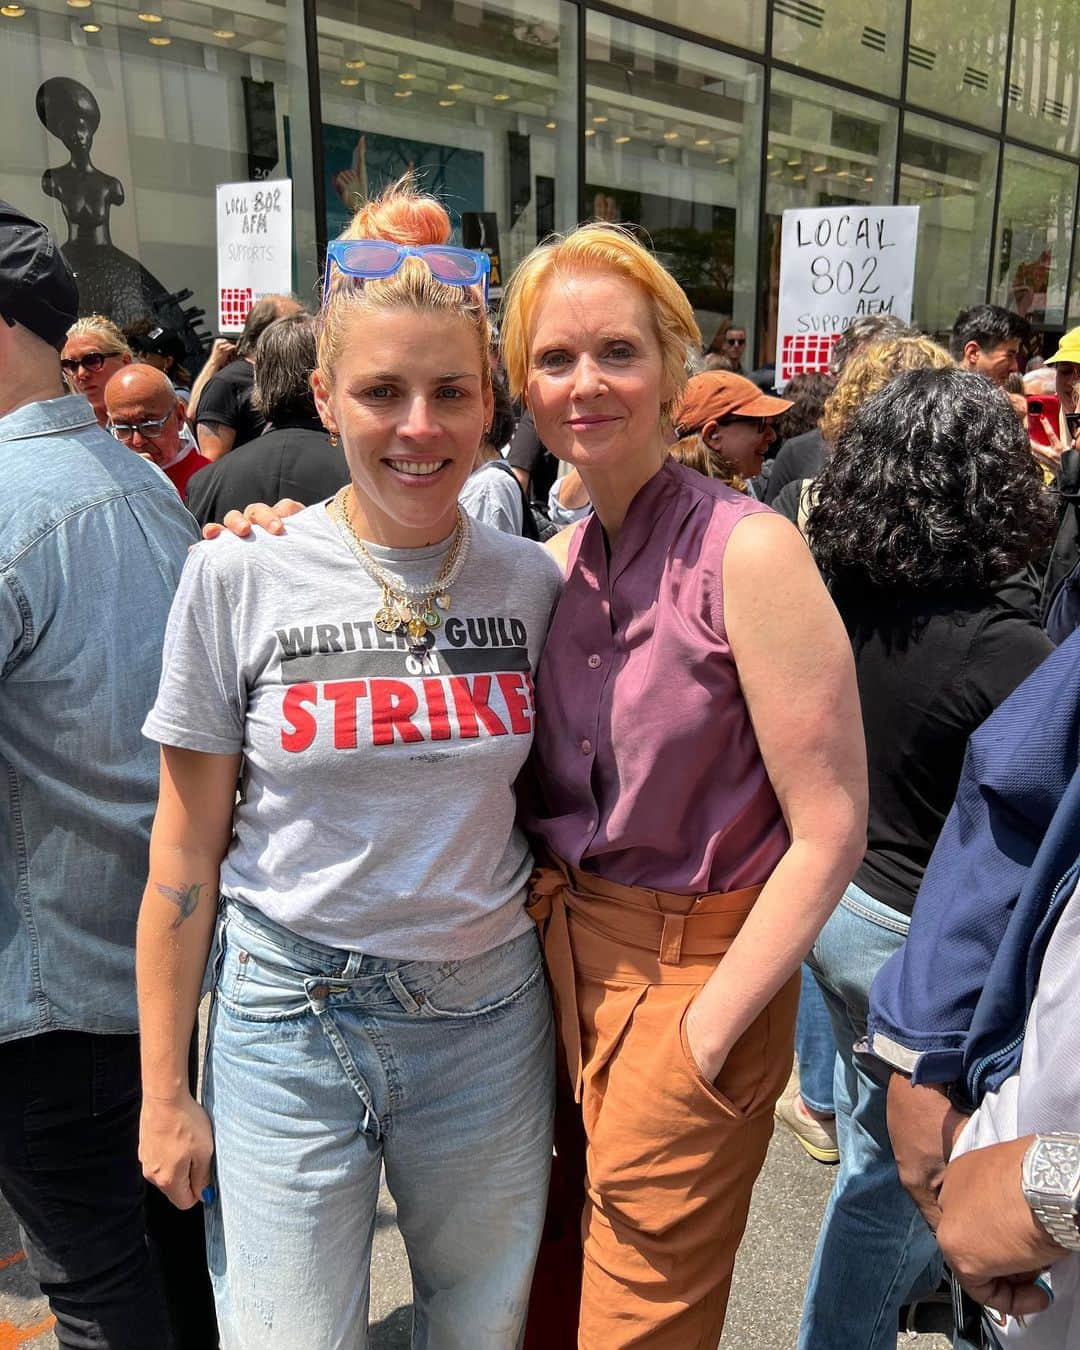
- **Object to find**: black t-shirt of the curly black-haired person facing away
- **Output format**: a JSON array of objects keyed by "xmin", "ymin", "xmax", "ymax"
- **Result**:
[{"xmin": 833, "ymin": 591, "xmax": 1053, "ymax": 914}]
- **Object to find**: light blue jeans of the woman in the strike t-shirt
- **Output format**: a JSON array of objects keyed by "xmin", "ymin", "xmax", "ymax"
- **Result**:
[{"xmin": 205, "ymin": 902, "xmax": 554, "ymax": 1350}]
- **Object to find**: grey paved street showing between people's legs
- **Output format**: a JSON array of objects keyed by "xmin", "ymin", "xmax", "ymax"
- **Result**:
[{"xmin": 0, "ymin": 1129, "xmax": 948, "ymax": 1350}]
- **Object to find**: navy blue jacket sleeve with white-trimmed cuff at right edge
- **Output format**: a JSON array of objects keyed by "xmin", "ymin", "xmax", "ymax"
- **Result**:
[{"xmin": 867, "ymin": 633, "xmax": 1080, "ymax": 1108}]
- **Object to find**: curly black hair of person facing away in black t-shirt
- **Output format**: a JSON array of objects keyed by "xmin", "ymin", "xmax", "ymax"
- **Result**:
[{"xmin": 807, "ymin": 369, "xmax": 1054, "ymax": 594}]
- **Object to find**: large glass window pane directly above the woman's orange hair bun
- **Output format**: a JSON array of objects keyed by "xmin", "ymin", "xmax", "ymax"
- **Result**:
[{"xmin": 317, "ymin": 0, "xmax": 578, "ymax": 284}]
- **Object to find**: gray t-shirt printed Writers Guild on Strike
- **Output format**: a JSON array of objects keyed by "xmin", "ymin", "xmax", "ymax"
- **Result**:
[{"xmin": 143, "ymin": 504, "xmax": 560, "ymax": 961}]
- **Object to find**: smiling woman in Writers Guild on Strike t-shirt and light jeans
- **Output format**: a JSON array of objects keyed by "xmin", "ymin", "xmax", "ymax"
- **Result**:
[{"xmin": 136, "ymin": 174, "xmax": 560, "ymax": 1350}]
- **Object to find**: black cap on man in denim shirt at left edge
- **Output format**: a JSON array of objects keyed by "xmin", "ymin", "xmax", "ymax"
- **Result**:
[{"xmin": 0, "ymin": 201, "xmax": 78, "ymax": 351}]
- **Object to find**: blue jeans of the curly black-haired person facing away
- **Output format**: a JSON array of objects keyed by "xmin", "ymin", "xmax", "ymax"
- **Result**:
[{"xmin": 798, "ymin": 884, "xmax": 941, "ymax": 1350}]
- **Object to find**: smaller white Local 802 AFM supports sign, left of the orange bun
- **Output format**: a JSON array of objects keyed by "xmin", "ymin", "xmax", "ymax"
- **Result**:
[{"xmin": 217, "ymin": 178, "xmax": 293, "ymax": 333}]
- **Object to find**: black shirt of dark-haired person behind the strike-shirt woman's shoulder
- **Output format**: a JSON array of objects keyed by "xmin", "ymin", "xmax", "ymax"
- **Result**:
[{"xmin": 186, "ymin": 419, "xmax": 348, "ymax": 525}]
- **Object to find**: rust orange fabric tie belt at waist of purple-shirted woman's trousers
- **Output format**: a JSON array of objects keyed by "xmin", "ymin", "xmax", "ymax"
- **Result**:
[{"xmin": 525, "ymin": 857, "xmax": 761, "ymax": 1102}]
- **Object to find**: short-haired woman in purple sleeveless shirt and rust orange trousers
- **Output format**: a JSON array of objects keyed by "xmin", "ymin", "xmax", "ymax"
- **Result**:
[{"xmin": 501, "ymin": 224, "xmax": 867, "ymax": 1350}]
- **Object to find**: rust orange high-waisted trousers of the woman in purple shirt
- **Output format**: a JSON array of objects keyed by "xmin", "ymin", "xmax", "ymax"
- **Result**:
[{"xmin": 528, "ymin": 860, "xmax": 799, "ymax": 1350}]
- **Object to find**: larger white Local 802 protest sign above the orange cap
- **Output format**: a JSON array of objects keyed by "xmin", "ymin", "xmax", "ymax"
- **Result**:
[{"xmin": 776, "ymin": 207, "xmax": 919, "ymax": 389}]
